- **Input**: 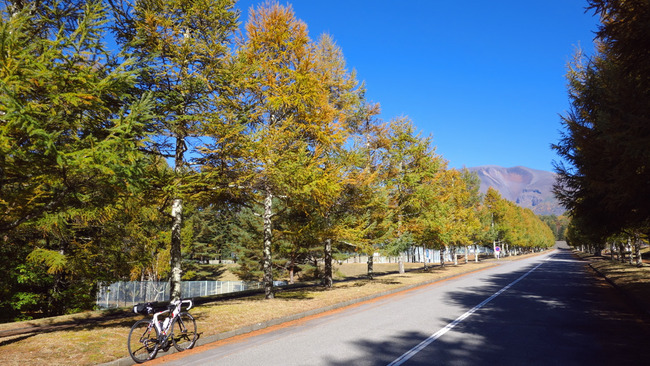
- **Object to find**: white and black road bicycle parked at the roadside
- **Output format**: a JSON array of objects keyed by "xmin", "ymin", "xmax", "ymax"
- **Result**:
[{"xmin": 127, "ymin": 300, "xmax": 198, "ymax": 363}]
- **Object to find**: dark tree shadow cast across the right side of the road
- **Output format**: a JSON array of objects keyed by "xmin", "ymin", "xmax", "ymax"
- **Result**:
[{"xmin": 324, "ymin": 250, "xmax": 650, "ymax": 366}]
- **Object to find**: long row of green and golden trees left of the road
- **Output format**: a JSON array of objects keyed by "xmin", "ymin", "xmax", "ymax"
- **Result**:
[{"xmin": 0, "ymin": 0, "xmax": 553, "ymax": 319}]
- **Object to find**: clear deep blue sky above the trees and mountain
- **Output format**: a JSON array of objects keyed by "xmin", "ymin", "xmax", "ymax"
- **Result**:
[{"xmin": 233, "ymin": 0, "xmax": 598, "ymax": 171}]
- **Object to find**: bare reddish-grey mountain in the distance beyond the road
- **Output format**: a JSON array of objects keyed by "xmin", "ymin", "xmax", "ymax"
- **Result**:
[{"xmin": 468, "ymin": 165, "xmax": 566, "ymax": 216}]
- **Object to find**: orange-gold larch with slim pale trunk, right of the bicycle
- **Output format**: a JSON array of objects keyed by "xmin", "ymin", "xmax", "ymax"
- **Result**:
[{"xmin": 206, "ymin": 3, "xmax": 345, "ymax": 298}]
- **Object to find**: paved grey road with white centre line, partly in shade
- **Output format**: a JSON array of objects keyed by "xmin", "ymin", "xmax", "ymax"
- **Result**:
[{"xmin": 160, "ymin": 249, "xmax": 650, "ymax": 366}]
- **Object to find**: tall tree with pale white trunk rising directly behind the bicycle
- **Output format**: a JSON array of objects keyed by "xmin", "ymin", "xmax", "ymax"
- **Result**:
[{"xmin": 113, "ymin": 0, "xmax": 237, "ymax": 299}]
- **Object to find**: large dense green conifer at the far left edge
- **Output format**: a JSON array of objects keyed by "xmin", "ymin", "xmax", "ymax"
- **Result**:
[{"xmin": 0, "ymin": 0, "xmax": 150, "ymax": 315}]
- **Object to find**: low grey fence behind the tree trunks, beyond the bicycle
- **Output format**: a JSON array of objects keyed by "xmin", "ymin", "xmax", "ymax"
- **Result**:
[{"xmin": 96, "ymin": 281, "xmax": 286, "ymax": 309}]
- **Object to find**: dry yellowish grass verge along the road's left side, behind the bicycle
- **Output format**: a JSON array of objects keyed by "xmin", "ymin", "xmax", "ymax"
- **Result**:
[{"xmin": 0, "ymin": 256, "xmax": 548, "ymax": 365}]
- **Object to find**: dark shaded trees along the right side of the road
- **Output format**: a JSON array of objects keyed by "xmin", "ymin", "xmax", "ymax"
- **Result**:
[{"xmin": 554, "ymin": 0, "xmax": 650, "ymax": 258}]
